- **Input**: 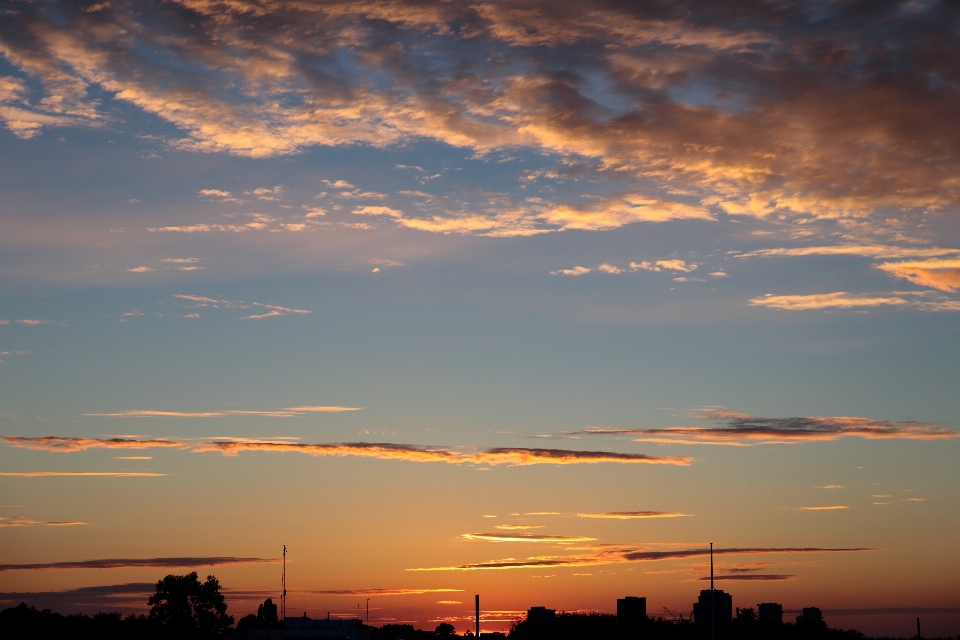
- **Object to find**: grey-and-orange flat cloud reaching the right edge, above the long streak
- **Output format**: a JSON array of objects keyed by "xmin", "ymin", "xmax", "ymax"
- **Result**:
[{"xmin": 577, "ymin": 412, "xmax": 960, "ymax": 446}]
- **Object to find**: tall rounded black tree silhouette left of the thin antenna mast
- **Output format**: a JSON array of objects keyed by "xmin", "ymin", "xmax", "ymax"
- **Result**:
[{"xmin": 147, "ymin": 571, "xmax": 233, "ymax": 638}]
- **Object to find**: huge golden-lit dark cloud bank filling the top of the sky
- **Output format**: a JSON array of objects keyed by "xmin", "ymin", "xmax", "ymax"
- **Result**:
[{"xmin": 0, "ymin": 0, "xmax": 960, "ymax": 245}]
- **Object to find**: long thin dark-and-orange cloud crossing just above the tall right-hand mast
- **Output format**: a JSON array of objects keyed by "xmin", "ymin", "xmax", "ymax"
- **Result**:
[{"xmin": 407, "ymin": 547, "xmax": 877, "ymax": 571}]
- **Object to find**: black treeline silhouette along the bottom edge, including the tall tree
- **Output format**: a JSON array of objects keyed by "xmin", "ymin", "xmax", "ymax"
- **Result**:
[{"xmin": 0, "ymin": 572, "xmax": 960, "ymax": 640}]
